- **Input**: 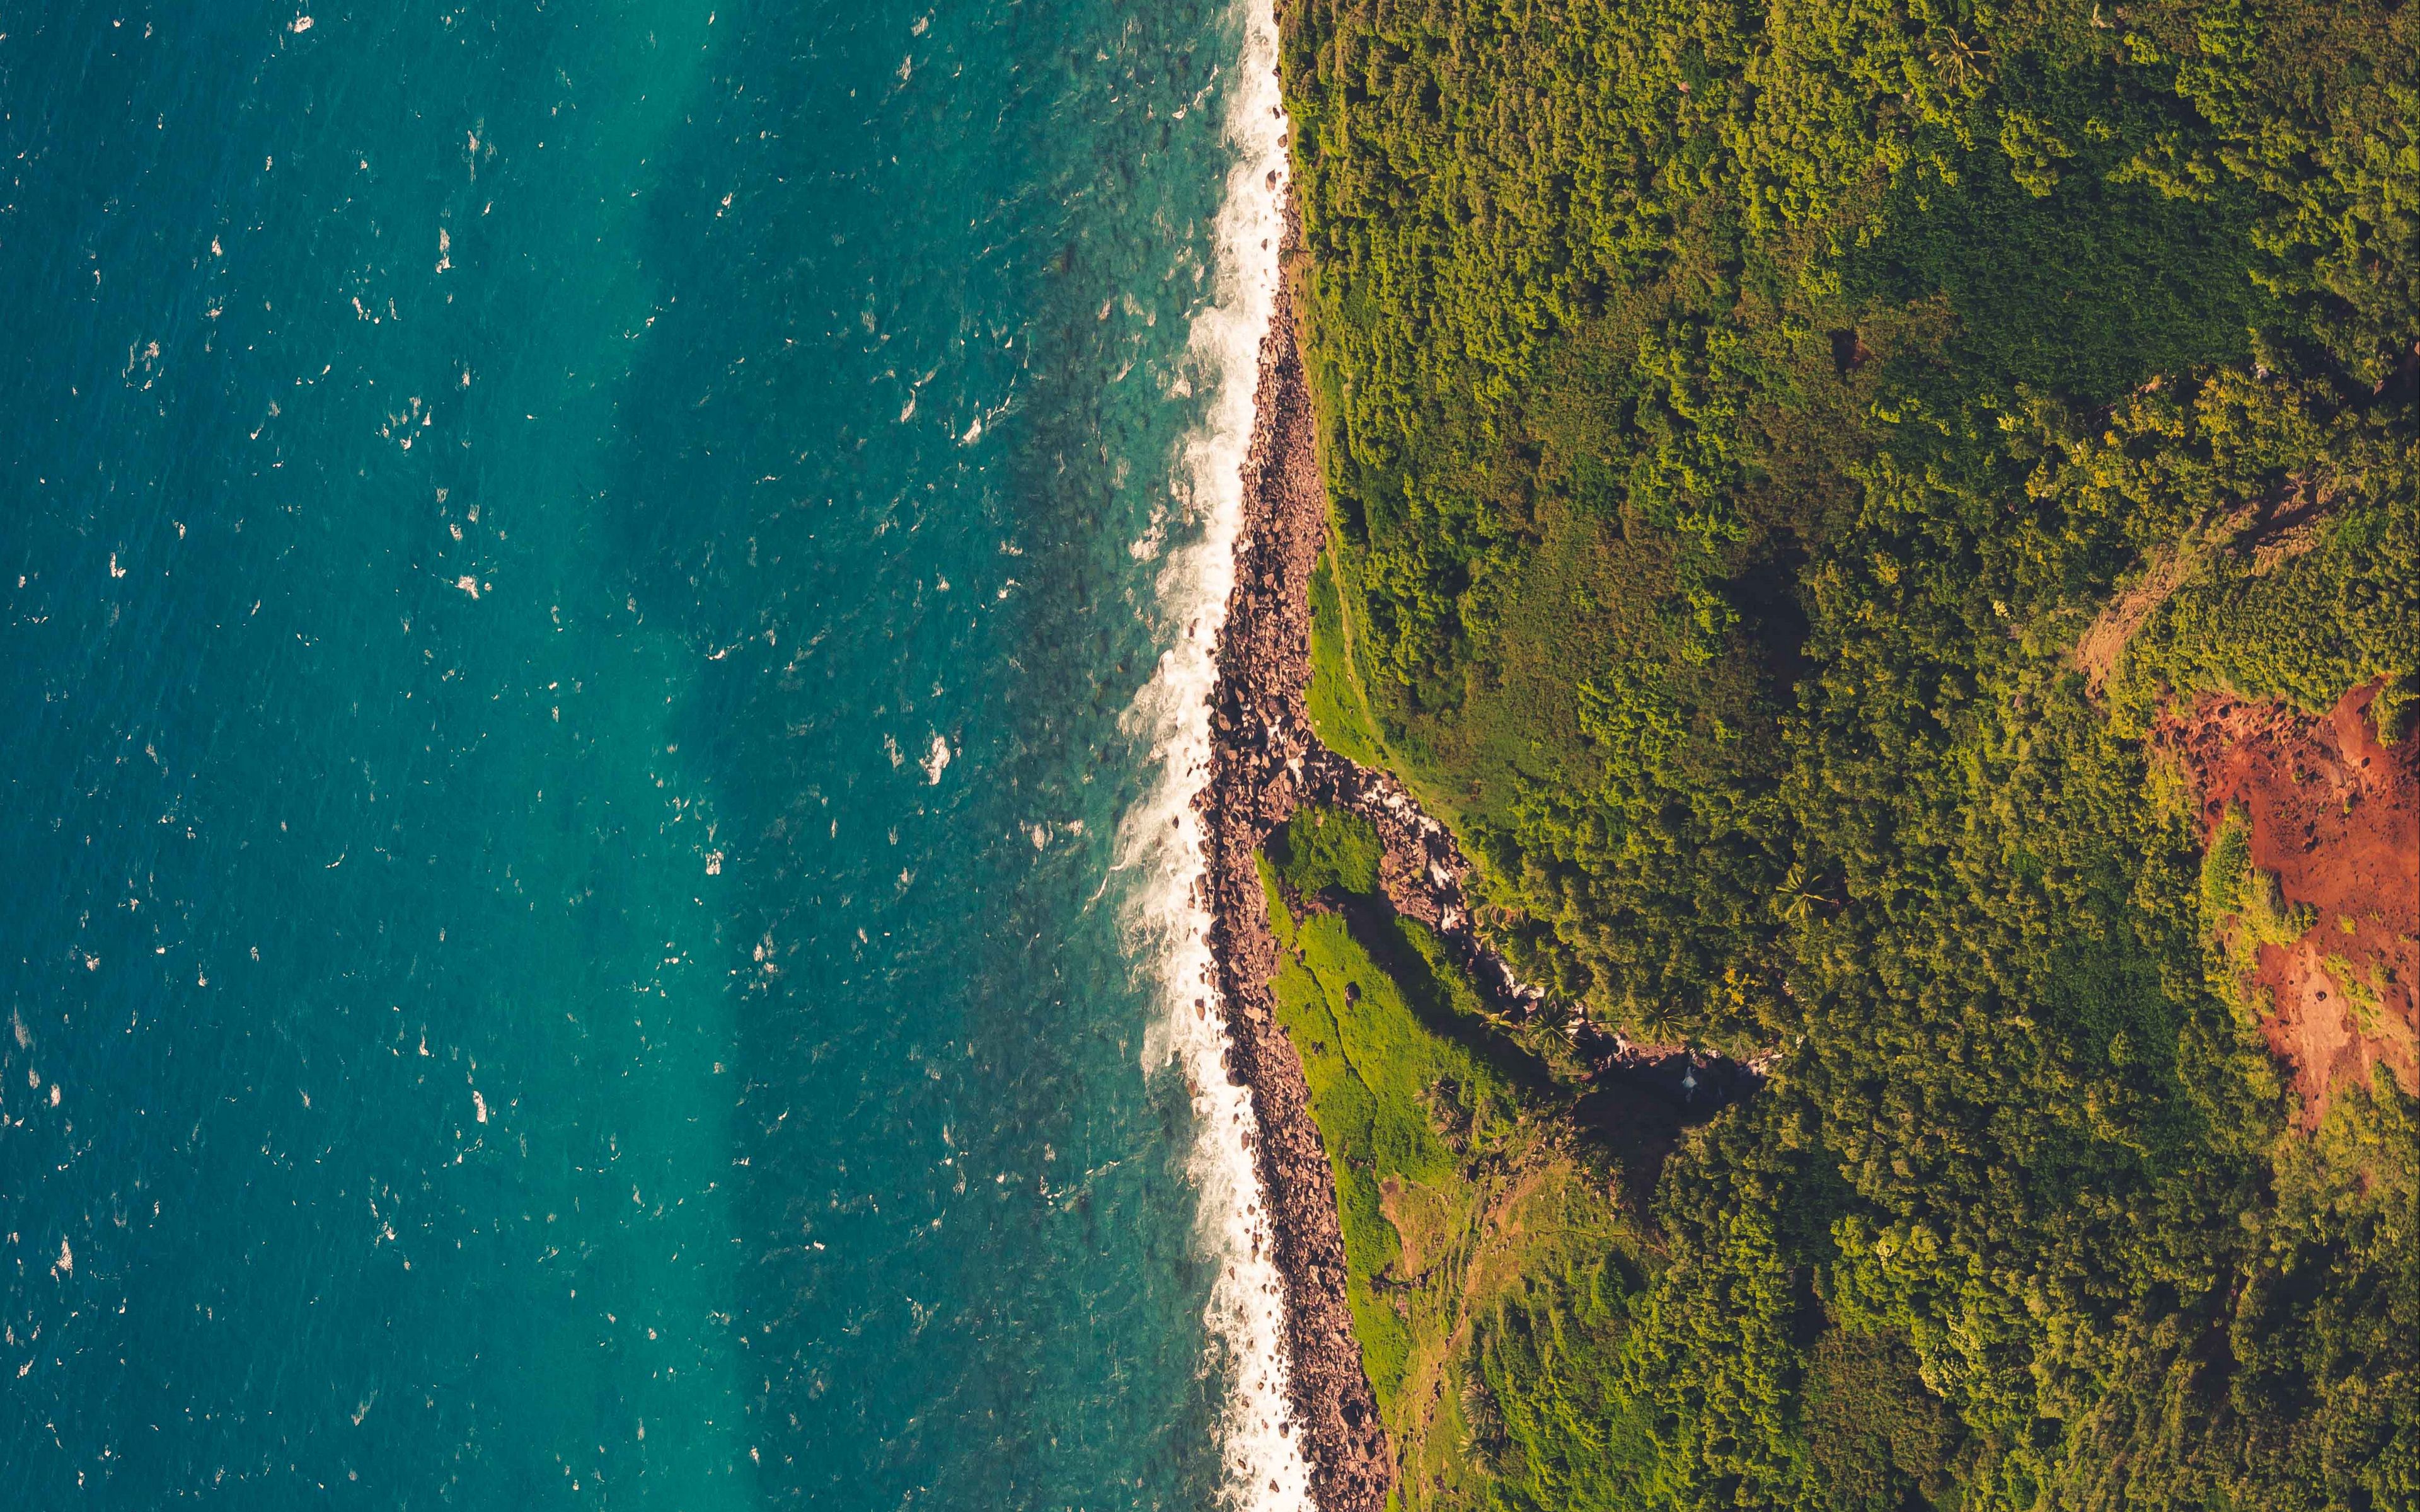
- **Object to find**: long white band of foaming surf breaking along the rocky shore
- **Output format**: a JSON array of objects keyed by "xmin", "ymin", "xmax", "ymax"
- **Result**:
[{"xmin": 1118, "ymin": 0, "xmax": 1311, "ymax": 1512}]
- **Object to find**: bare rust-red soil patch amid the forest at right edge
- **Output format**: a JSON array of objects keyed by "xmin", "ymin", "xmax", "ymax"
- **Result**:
[{"xmin": 2158, "ymin": 682, "xmax": 2420, "ymax": 1127}]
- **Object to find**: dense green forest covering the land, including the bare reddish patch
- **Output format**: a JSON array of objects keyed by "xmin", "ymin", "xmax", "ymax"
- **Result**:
[{"xmin": 1270, "ymin": 0, "xmax": 2420, "ymax": 1512}]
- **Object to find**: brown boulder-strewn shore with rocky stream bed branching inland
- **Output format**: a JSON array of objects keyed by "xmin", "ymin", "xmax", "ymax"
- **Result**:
[{"xmin": 1193, "ymin": 197, "xmax": 1769, "ymax": 1512}]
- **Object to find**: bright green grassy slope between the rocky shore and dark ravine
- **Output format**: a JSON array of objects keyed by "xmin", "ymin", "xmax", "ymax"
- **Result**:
[{"xmin": 1263, "ymin": 810, "xmax": 1653, "ymax": 1509}]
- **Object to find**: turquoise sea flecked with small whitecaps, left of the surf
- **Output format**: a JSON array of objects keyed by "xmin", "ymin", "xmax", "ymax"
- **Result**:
[{"xmin": 0, "ymin": 0, "xmax": 1299, "ymax": 1509}]
